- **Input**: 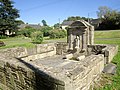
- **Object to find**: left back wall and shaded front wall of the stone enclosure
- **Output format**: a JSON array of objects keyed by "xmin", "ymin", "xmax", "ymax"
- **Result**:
[{"xmin": 0, "ymin": 43, "xmax": 64, "ymax": 90}]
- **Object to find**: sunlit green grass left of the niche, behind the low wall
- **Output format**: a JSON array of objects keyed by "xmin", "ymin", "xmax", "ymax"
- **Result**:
[{"xmin": 0, "ymin": 37, "xmax": 67, "ymax": 49}]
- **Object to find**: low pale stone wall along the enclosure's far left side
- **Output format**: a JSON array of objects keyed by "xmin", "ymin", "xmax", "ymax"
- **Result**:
[{"xmin": 0, "ymin": 43, "xmax": 56, "ymax": 60}]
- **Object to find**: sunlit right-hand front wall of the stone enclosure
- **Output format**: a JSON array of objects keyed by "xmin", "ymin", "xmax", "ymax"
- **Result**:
[{"xmin": 64, "ymin": 55, "xmax": 104, "ymax": 90}]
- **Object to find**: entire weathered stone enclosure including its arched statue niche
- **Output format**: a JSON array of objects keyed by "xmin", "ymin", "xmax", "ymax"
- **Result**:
[{"xmin": 0, "ymin": 20, "xmax": 118, "ymax": 90}]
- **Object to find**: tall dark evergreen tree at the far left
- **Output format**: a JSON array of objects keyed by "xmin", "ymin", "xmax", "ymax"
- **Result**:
[{"xmin": 0, "ymin": 0, "xmax": 19, "ymax": 34}]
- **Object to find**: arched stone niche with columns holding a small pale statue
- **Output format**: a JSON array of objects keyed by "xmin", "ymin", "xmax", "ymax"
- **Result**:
[{"xmin": 67, "ymin": 20, "xmax": 94, "ymax": 55}]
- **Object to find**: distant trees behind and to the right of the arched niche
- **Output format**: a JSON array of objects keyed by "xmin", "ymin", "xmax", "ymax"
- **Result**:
[{"xmin": 61, "ymin": 6, "xmax": 120, "ymax": 30}]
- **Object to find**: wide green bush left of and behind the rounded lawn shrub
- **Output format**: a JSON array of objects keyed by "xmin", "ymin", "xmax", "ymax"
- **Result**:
[{"xmin": 17, "ymin": 26, "xmax": 36, "ymax": 37}]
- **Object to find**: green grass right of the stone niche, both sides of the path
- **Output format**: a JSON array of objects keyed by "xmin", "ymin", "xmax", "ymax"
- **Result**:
[{"xmin": 94, "ymin": 31, "xmax": 120, "ymax": 90}]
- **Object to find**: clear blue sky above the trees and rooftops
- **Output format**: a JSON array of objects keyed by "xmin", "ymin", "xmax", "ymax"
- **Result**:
[{"xmin": 12, "ymin": 0, "xmax": 120, "ymax": 26}]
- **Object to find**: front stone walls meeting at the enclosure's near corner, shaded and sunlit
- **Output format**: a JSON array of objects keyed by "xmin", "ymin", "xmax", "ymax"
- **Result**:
[{"xmin": 0, "ymin": 51, "xmax": 104, "ymax": 90}]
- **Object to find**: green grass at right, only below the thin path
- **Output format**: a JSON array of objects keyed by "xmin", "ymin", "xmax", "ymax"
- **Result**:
[{"xmin": 95, "ymin": 39, "xmax": 120, "ymax": 90}]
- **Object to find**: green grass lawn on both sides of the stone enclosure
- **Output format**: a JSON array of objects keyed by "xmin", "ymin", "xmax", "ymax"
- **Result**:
[{"xmin": 1, "ymin": 30, "xmax": 120, "ymax": 90}]
